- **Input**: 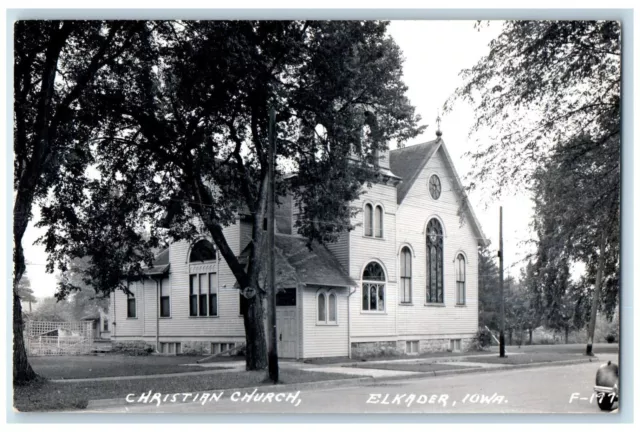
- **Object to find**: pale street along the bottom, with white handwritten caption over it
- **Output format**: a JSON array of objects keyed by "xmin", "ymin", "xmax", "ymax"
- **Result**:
[{"xmin": 85, "ymin": 354, "xmax": 618, "ymax": 414}]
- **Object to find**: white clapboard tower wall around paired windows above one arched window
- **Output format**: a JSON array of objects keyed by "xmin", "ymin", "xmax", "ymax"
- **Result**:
[{"xmin": 349, "ymin": 184, "xmax": 398, "ymax": 338}]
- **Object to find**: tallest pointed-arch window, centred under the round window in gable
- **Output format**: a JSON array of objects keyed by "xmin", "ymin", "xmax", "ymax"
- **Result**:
[{"xmin": 425, "ymin": 217, "xmax": 445, "ymax": 305}]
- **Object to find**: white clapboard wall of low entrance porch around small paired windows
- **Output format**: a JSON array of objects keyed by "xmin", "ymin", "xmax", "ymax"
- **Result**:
[{"xmin": 301, "ymin": 287, "xmax": 349, "ymax": 358}]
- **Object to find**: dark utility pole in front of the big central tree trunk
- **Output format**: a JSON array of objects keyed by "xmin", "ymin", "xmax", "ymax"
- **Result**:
[{"xmin": 267, "ymin": 108, "xmax": 279, "ymax": 384}]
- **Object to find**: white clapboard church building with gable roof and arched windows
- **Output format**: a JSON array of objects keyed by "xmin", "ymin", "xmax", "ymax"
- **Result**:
[{"xmin": 110, "ymin": 137, "xmax": 487, "ymax": 359}]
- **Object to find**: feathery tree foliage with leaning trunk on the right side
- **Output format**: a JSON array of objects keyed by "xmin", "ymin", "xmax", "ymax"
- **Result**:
[{"xmin": 447, "ymin": 21, "xmax": 621, "ymax": 353}]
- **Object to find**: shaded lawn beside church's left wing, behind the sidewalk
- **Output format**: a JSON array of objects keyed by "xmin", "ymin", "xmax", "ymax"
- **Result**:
[{"xmin": 29, "ymin": 354, "xmax": 236, "ymax": 379}]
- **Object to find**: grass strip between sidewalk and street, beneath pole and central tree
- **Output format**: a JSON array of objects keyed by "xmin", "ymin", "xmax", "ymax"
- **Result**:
[{"xmin": 13, "ymin": 369, "xmax": 352, "ymax": 411}]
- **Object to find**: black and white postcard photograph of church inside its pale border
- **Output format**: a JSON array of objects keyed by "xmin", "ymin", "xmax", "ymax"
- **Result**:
[{"xmin": 6, "ymin": 13, "xmax": 633, "ymax": 421}]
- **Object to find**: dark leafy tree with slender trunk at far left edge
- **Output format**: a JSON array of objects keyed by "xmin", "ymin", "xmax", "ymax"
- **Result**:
[{"xmin": 13, "ymin": 20, "xmax": 146, "ymax": 383}]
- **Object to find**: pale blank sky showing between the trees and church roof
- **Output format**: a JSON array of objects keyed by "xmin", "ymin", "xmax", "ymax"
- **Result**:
[{"xmin": 23, "ymin": 21, "xmax": 532, "ymax": 297}]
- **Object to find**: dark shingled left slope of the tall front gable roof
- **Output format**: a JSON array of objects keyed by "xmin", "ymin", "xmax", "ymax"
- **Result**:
[{"xmin": 389, "ymin": 139, "xmax": 442, "ymax": 204}]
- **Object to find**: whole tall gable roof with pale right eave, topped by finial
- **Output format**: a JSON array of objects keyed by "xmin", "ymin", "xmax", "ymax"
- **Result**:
[{"xmin": 390, "ymin": 137, "xmax": 489, "ymax": 246}]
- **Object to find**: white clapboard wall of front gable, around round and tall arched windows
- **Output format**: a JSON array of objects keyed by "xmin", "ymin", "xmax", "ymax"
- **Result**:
[{"xmin": 396, "ymin": 150, "xmax": 478, "ymax": 336}]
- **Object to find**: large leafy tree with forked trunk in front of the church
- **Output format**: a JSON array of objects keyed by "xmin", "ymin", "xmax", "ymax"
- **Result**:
[{"xmin": 37, "ymin": 21, "xmax": 423, "ymax": 369}]
